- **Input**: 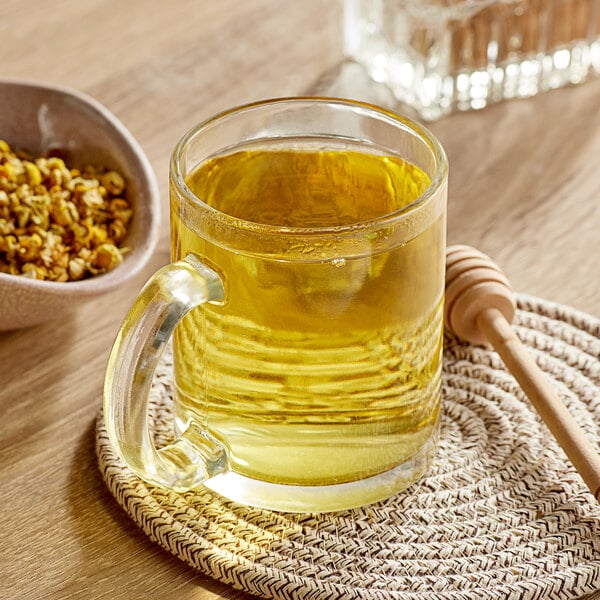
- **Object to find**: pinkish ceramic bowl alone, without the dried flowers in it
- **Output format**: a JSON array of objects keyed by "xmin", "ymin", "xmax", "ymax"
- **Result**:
[{"xmin": 0, "ymin": 79, "xmax": 160, "ymax": 330}]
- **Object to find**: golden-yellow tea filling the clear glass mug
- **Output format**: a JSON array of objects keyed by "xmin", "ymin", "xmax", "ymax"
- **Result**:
[{"xmin": 171, "ymin": 140, "xmax": 445, "ymax": 486}]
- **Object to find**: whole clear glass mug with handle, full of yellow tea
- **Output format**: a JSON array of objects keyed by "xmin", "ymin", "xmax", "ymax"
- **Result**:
[{"xmin": 104, "ymin": 98, "xmax": 448, "ymax": 512}]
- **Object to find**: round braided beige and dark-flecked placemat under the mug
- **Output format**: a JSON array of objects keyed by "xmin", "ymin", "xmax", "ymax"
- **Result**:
[{"xmin": 97, "ymin": 295, "xmax": 600, "ymax": 600}]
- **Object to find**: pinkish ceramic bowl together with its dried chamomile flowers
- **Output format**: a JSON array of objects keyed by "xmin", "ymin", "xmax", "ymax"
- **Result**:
[{"xmin": 0, "ymin": 79, "xmax": 161, "ymax": 331}]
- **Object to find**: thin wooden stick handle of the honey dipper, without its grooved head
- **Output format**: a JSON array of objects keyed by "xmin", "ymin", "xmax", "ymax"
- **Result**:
[{"xmin": 477, "ymin": 307, "xmax": 600, "ymax": 502}]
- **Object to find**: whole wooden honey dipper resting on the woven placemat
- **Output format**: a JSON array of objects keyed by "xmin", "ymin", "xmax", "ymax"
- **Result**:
[{"xmin": 444, "ymin": 246, "xmax": 600, "ymax": 501}]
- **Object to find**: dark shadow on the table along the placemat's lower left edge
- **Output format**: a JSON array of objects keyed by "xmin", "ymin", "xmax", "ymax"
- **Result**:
[{"xmin": 62, "ymin": 420, "xmax": 253, "ymax": 600}]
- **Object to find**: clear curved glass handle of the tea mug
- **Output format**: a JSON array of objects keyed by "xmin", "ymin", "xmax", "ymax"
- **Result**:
[{"xmin": 104, "ymin": 255, "xmax": 228, "ymax": 491}]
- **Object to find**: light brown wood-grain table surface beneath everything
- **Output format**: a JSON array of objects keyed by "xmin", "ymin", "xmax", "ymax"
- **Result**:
[{"xmin": 0, "ymin": 0, "xmax": 600, "ymax": 600}]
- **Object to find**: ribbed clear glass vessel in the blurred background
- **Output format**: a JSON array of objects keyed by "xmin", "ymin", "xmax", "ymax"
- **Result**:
[{"xmin": 344, "ymin": 0, "xmax": 600, "ymax": 120}]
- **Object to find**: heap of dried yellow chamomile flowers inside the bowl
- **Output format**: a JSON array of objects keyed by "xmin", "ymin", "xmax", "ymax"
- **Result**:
[{"xmin": 0, "ymin": 139, "xmax": 133, "ymax": 281}]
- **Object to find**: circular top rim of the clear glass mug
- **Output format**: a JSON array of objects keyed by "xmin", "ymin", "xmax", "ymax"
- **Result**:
[{"xmin": 169, "ymin": 96, "xmax": 448, "ymax": 237}]
